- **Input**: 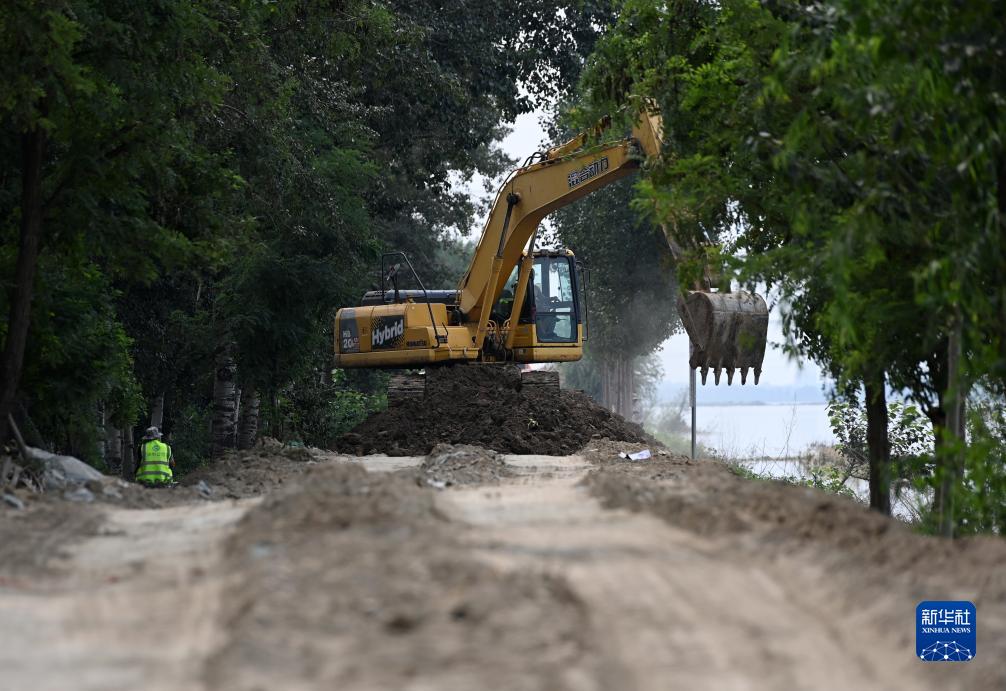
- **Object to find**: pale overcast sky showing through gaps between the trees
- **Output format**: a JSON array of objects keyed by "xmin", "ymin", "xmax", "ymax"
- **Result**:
[{"xmin": 472, "ymin": 113, "xmax": 822, "ymax": 387}]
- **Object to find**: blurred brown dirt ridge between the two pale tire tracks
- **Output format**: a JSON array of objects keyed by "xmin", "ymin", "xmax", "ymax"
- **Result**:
[{"xmin": 205, "ymin": 464, "xmax": 600, "ymax": 691}]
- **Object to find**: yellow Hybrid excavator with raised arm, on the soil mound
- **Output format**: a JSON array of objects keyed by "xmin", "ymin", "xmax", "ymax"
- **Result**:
[{"xmin": 334, "ymin": 112, "xmax": 769, "ymax": 398}]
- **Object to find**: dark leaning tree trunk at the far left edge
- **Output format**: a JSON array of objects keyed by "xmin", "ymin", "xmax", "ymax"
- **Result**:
[{"xmin": 0, "ymin": 127, "xmax": 45, "ymax": 442}]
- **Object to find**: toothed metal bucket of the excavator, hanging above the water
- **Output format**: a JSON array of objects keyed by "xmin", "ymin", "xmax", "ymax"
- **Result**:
[{"xmin": 678, "ymin": 291, "xmax": 769, "ymax": 385}]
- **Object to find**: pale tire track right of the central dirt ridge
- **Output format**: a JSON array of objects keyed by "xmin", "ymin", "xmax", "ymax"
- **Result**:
[{"xmin": 438, "ymin": 478, "xmax": 941, "ymax": 691}]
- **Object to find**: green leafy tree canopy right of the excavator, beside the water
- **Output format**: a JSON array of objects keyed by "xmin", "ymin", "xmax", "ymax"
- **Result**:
[{"xmin": 585, "ymin": 1, "xmax": 1002, "ymax": 527}]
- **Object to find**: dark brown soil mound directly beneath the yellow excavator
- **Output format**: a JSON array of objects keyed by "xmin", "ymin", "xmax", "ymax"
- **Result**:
[{"xmin": 336, "ymin": 364, "xmax": 651, "ymax": 456}]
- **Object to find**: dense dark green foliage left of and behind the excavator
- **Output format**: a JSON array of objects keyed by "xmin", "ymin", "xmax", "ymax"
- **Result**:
[{"xmin": 0, "ymin": 0, "xmax": 611, "ymax": 465}]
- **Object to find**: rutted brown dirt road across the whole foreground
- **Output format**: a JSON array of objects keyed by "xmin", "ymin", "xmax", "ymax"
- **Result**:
[{"xmin": 0, "ymin": 445, "xmax": 1006, "ymax": 691}]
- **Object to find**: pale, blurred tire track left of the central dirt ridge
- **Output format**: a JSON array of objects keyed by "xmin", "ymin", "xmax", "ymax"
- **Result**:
[{"xmin": 0, "ymin": 500, "xmax": 251, "ymax": 691}]
